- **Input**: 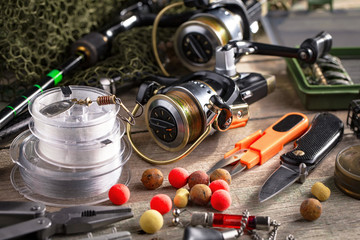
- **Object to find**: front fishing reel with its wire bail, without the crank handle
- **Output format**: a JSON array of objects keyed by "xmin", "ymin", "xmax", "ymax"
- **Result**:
[{"xmin": 127, "ymin": 71, "xmax": 275, "ymax": 164}]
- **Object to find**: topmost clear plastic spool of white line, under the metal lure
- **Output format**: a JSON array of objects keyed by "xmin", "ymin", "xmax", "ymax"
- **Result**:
[{"xmin": 29, "ymin": 86, "xmax": 120, "ymax": 144}]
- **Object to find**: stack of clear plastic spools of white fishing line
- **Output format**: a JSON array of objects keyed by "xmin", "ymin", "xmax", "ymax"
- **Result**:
[{"xmin": 10, "ymin": 86, "xmax": 132, "ymax": 206}]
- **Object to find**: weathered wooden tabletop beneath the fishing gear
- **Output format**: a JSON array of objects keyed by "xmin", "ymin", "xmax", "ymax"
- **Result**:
[{"xmin": 0, "ymin": 34, "xmax": 360, "ymax": 240}]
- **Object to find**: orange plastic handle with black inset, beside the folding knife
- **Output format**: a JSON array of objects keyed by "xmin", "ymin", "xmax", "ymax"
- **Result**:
[{"xmin": 240, "ymin": 112, "xmax": 309, "ymax": 168}]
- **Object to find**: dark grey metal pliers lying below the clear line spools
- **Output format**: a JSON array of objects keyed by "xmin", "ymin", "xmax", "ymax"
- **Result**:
[{"xmin": 0, "ymin": 202, "xmax": 133, "ymax": 240}]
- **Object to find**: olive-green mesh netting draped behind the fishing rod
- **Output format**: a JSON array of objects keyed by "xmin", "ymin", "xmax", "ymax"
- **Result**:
[{"xmin": 0, "ymin": 0, "xmax": 174, "ymax": 101}]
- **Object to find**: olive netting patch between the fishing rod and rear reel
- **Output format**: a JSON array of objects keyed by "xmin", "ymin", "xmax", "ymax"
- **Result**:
[{"xmin": 70, "ymin": 26, "xmax": 173, "ymax": 90}]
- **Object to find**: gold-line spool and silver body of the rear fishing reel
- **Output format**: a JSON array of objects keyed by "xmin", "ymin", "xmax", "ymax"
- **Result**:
[{"xmin": 174, "ymin": 0, "xmax": 261, "ymax": 72}]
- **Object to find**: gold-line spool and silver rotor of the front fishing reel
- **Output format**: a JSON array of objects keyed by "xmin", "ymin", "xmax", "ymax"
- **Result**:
[{"xmin": 145, "ymin": 81, "xmax": 216, "ymax": 152}]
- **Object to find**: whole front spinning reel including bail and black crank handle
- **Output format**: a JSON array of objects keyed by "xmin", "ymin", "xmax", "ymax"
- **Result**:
[{"xmin": 127, "ymin": 32, "xmax": 332, "ymax": 164}]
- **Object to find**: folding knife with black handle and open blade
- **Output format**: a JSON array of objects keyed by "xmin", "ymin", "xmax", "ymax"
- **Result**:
[{"xmin": 259, "ymin": 113, "xmax": 344, "ymax": 202}]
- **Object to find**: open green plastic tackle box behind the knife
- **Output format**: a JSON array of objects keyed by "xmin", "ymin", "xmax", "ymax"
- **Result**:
[{"xmin": 286, "ymin": 47, "xmax": 360, "ymax": 110}]
